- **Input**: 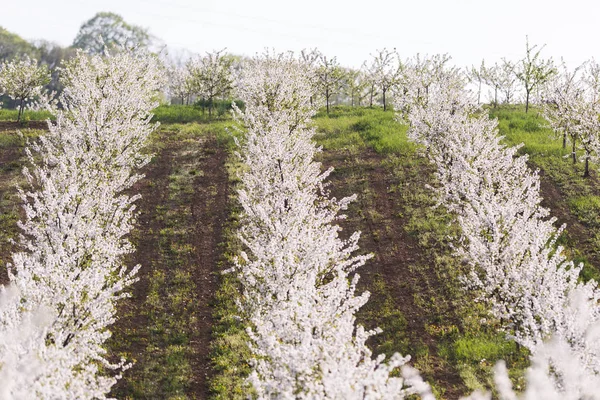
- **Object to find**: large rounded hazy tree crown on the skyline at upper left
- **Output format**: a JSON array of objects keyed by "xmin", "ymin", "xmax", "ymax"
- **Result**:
[{"xmin": 73, "ymin": 12, "xmax": 151, "ymax": 54}]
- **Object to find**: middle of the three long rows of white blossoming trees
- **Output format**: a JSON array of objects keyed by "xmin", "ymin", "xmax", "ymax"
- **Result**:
[{"xmin": 235, "ymin": 54, "xmax": 429, "ymax": 399}]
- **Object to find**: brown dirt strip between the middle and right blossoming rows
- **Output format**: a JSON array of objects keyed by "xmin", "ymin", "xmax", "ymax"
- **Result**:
[{"xmin": 322, "ymin": 149, "xmax": 465, "ymax": 399}]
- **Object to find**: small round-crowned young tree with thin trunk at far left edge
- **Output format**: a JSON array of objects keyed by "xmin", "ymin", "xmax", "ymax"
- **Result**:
[{"xmin": 0, "ymin": 56, "xmax": 50, "ymax": 122}]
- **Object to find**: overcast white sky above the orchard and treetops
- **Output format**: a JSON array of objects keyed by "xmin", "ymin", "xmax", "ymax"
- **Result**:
[{"xmin": 0, "ymin": 0, "xmax": 600, "ymax": 67}]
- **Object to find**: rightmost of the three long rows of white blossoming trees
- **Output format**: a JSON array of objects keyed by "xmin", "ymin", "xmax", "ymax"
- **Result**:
[{"xmin": 396, "ymin": 57, "xmax": 600, "ymax": 399}]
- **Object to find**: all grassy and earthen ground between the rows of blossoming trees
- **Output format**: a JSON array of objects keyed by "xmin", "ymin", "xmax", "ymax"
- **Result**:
[{"xmin": 0, "ymin": 106, "xmax": 600, "ymax": 399}]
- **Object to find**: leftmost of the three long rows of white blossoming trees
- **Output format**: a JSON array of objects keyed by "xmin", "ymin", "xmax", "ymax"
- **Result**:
[{"xmin": 0, "ymin": 47, "xmax": 163, "ymax": 399}]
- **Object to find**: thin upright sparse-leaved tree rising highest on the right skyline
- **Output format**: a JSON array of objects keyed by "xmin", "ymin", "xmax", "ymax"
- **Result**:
[{"xmin": 515, "ymin": 37, "xmax": 556, "ymax": 112}]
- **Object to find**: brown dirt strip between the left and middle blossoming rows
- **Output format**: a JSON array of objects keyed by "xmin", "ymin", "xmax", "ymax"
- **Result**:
[{"xmin": 110, "ymin": 135, "xmax": 228, "ymax": 399}]
